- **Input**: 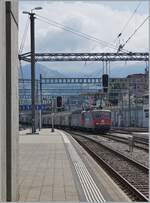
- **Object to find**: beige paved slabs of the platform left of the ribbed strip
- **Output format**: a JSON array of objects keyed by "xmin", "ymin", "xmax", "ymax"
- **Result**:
[{"xmin": 19, "ymin": 129, "xmax": 79, "ymax": 202}]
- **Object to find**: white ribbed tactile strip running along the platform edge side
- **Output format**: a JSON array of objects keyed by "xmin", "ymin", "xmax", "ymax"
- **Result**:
[{"xmin": 59, "ymin": 131, "xmax": 105, "ymax": 202}]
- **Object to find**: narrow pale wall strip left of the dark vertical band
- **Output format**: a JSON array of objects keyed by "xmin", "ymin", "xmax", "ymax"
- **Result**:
[{"xmin": 0, "ymin": 1, "xmax": 6, "ymax": 201}]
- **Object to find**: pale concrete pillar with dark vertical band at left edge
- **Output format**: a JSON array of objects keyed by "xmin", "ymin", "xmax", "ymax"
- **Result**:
[{"xmin": 0, "ymin": 0, "xmax": 18, "ymax": 201}]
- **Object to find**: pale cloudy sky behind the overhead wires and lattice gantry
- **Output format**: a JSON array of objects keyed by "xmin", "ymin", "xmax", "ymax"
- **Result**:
[{"xmin": 19, "ymin": 1, "xmax": 148, "ymax": 75}]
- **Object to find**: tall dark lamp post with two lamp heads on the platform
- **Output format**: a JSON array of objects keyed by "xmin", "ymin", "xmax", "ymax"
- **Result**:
[{"xmin": 23, "ymin": 7, "xmax": 42, "ymax": 134}]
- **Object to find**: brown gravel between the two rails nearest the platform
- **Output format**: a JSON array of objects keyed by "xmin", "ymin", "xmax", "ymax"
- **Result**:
[{"xmin": 73, "ymin": 135, "xmax": 149, "ymax": 200}]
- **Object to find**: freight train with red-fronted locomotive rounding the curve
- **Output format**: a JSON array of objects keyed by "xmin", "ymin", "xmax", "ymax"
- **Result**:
[{"xmin": 42, "ymin": 109, "xmax": 112, "ymax": 132}]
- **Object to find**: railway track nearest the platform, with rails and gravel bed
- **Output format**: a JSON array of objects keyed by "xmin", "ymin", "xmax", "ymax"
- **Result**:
[{"xmin": 68, "ymin": 131, "xmax": 149, "ymax": 202}]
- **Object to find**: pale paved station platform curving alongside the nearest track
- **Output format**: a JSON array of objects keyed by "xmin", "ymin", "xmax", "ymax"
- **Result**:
[{"xmin": 18, "ymin": 129, "xmax": 131, "ymax": 202}]
